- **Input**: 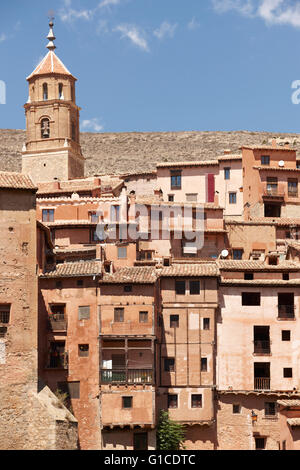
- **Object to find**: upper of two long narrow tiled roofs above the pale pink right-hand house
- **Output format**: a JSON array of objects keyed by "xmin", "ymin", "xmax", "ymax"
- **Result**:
[{"xmin": 217, "ymin": 260, "xmax": 300, "ymax": 271}]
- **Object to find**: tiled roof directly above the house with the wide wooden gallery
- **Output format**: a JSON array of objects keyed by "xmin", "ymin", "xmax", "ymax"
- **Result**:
[{"xmin": 101, "ymin": 266, "xmax": 158, "ymax": 284}]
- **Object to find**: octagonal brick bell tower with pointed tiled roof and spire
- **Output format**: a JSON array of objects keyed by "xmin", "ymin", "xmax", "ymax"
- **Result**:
[{"xmin": 22, "ymin": 20, "xmax": 84, "ymax": 183}]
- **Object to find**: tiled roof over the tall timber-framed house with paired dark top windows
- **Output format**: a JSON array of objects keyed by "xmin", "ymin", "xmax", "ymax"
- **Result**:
[{"xmin": 160, "ymin": 263, "xmax": 219, "ymax": 277}]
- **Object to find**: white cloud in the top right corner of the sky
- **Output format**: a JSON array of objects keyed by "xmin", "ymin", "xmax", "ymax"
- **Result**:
[{"xmin": 211, "ymin": 0, "xmax": 300, "ymax": 28}]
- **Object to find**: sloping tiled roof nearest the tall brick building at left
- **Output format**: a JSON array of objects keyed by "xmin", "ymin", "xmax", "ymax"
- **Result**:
[{"xmin": 40, "ymin": 260, "xmax": 102, "ymax": 278}]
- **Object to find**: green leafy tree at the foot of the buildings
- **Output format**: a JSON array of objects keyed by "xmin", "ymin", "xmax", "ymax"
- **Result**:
[{"xmin": 157, "ymin": 410, "xmax": 185, "ymax": 450}]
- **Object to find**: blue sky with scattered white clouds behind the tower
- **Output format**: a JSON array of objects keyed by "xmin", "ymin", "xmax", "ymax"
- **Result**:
[{"xmin": 0, "ymin": 0, "xmax": 300, "ymax": 132}]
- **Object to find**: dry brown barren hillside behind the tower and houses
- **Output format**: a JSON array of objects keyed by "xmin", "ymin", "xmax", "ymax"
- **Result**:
[{"xmin": 0, "ymin": 129, "xmax": 300, "ymax": 176}]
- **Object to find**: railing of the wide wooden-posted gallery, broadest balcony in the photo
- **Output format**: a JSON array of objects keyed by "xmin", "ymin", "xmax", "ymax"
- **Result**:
[{"xmin": 100, "ymin": 369, "xmax": 153, "ymax": 384}]
